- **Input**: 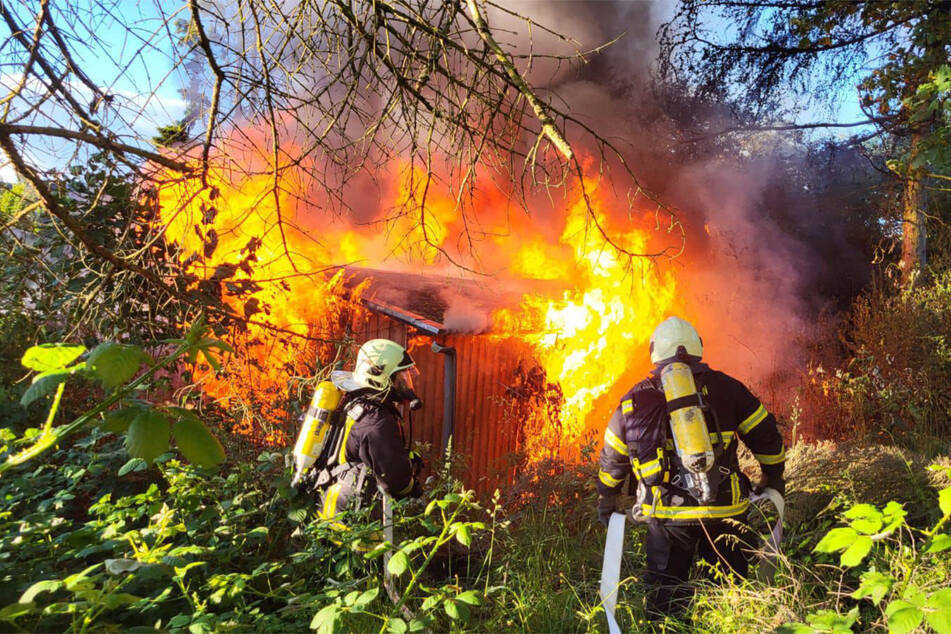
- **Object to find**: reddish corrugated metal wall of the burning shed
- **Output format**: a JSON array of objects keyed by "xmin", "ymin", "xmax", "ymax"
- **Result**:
[{"xmin": 354, "ymin": 313, "xmax": 520, "ymax": 492}]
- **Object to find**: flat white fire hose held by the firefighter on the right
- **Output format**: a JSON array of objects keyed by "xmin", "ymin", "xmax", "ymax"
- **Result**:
[{"xmin": 600, "ymin": 488, "xmax": 786, "ymax": 634}]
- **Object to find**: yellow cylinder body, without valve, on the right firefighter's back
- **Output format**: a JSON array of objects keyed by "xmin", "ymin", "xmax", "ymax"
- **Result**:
[{"xmin": 660, "ymin": 362, "xmax": 714, "ymax": 473}]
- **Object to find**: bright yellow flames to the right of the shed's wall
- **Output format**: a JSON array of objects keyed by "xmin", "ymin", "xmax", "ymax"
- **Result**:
[{"xmin": 495, "ymin": 178, "xmax": 676, "ymax": 454}]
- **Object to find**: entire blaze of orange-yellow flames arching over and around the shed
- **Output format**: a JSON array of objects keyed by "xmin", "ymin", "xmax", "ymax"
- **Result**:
[{"xmin": 159, "ymin": 136, "xmax": 675, "ymax": 455}]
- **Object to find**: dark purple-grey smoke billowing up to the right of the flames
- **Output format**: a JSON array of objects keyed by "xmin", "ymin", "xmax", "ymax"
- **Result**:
[{"xmin": 490, "ymin": 2, "xmax": 868, "ymax": 390}]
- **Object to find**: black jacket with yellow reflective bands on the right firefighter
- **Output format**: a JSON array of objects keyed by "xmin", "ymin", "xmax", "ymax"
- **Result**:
[{"xmin": 598, "ymin": 362, "xmax": 786, "ymax": 523}]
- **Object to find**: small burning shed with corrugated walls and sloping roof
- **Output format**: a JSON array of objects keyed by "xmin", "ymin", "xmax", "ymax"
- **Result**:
[{"xmin": 348, "ymin": 269, "xmax": 558, "ymax": 490}]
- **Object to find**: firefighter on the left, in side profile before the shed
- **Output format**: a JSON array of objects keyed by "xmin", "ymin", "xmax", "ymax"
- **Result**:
[{"xmin": 316, "ymin": 339, "xmax": 422, "ymax": 520}]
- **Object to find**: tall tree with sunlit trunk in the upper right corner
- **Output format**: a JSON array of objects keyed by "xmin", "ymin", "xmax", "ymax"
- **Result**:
[{"xmin": 661, "ymin": 0, "xmax": 951, "ymax": 284}]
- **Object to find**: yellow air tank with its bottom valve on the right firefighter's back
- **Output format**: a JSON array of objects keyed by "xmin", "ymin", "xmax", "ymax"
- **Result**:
[{"xmin": 660, "ymin": 361, "xmax": 715, "ymax": 503}]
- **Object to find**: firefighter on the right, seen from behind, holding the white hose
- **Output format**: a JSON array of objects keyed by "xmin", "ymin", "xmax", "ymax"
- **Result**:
[{"xmin": 598, "ymin": 317, "xmax": 786, "ymax": 619}]
